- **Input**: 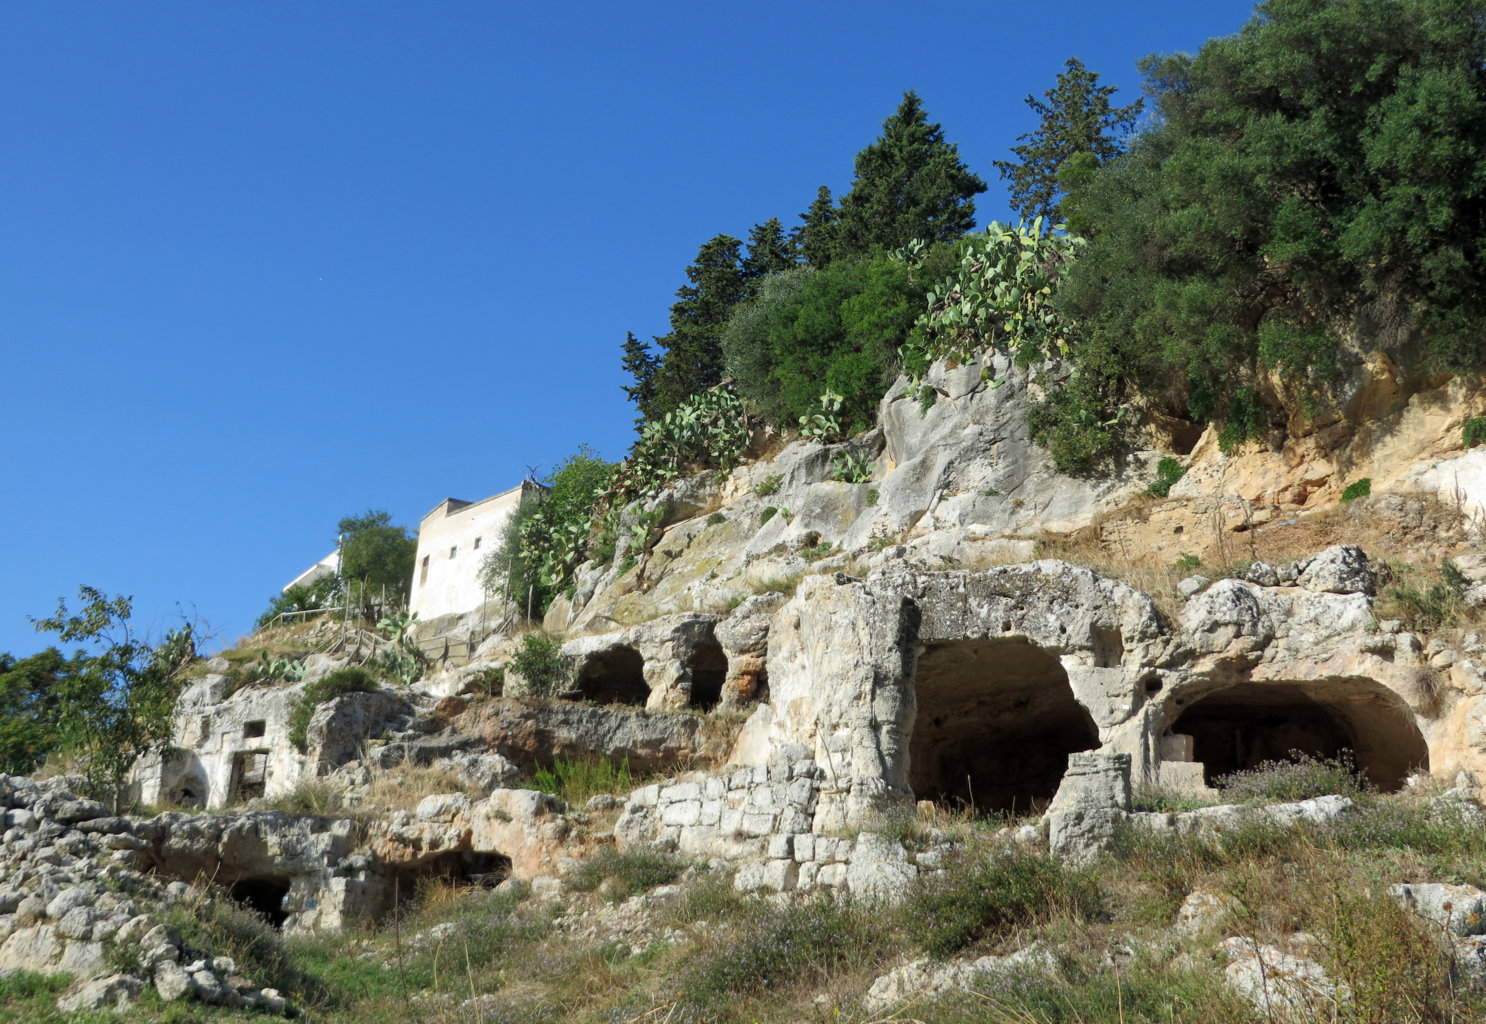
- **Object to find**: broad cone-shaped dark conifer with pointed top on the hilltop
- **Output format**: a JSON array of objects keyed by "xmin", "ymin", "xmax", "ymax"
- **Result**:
[{"xmin": 834, "ymin": 91, "xmax": 985, "ymax": 256}]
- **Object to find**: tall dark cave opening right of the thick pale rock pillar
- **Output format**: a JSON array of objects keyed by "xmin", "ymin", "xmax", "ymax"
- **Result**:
[{"xmin": 908, "ymin": 639, "xmax": 1100, "ymax": 814}]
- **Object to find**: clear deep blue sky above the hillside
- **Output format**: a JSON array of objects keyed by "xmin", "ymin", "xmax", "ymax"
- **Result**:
[{"xmin": 0, "ymin": 0, "xmax": 1251, "ymax": 655}]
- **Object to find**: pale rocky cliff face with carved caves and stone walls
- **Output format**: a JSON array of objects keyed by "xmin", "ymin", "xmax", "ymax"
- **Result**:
[{"xmin": 17, "ymin": 353, "xmax": 1486, "ymax": 1009}]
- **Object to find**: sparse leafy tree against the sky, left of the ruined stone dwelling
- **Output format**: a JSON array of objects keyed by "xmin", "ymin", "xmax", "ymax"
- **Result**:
[{"xmin": 33, "ymin": 587, "xmax": 196, "ymax": 808}]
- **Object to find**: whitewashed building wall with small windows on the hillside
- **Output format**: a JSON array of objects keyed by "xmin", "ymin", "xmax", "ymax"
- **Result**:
[{"xmin": 409, "ymin": 483, "xmax": 536, "ymax": 621}]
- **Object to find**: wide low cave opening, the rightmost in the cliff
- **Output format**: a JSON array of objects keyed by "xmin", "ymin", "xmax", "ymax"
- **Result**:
[{"xmin": 1171, "ymin": 679, "xmax": 1430, "ymax": 792}]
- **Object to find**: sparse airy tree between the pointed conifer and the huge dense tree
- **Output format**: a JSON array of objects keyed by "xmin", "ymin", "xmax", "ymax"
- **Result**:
[{"xmin": 996, "ymin": 56, "xmax": 1144, "ymax": 220}]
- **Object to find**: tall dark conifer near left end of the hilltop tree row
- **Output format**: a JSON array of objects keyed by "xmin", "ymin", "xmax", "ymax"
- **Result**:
[{"xmin": 648, "ymin": 235, "xmax": 747, "ymax": 418}]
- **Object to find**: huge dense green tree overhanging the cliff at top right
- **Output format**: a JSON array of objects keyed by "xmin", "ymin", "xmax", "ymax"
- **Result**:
[{"xmin": 1048, "ymin": 0, "xmax": 1486, "ymax": 472}]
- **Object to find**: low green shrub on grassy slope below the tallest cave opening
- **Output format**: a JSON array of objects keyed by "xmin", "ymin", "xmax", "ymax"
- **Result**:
[{"xmin": 902, "ymin": 852, "xmax": 1104, "ymax": 957}]
